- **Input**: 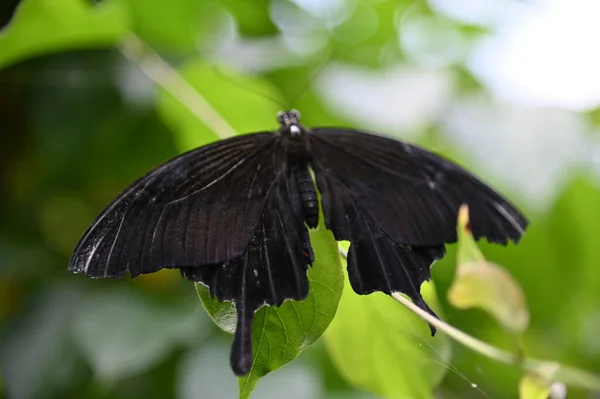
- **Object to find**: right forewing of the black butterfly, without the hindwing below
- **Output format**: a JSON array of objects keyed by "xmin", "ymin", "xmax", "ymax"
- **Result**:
[{"xmin": 310, "ymin": 128, "xmax": 527, "ymax": 246}]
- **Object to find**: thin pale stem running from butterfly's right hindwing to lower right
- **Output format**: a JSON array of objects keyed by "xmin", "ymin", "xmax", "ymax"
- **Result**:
[{"xmin": 339, "ymin": 247, "xmax": 600, "ymax": 392}]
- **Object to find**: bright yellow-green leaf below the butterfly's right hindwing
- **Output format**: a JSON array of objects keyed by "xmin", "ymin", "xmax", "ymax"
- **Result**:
[{"xmin": 325, "ymin": 248, "xmax": 451, "ymax": 399}]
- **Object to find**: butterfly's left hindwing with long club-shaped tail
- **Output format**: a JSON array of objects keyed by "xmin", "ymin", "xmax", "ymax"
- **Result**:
[{"xmin": 181, "ymin": 162, "xmax": 314, "ymax": 375}]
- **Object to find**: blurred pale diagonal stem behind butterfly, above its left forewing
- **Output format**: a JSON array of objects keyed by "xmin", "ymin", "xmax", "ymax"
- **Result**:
[{"xmin": 120, "ymin": 34, "xmax": 237, "ymax": 139}]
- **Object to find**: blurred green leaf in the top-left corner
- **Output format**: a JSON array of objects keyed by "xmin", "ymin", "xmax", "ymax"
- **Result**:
[{"xmin": 0, "ymin": 0, "xmax": 129, "ymax": 68}]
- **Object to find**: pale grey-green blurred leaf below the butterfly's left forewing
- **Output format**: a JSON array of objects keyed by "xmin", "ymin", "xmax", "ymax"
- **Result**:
[{"xmin": 74, "ymin": 289, "xmax": 202, "ymax": 384}]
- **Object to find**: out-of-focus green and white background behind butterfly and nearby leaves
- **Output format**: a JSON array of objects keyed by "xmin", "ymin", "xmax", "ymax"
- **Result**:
[{"xmin": 0, "ymin": 0, "xmax": 600, "ymax": 399}]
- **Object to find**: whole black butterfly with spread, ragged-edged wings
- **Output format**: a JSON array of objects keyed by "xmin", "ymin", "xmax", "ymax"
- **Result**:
[{"xmin": 69, "ymin": 111, "xmax": 527, "ymax": 375}]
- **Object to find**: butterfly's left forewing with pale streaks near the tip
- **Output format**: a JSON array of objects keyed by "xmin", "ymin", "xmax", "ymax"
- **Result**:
[{"xmin": 69, "ymin": 133, "xmax": 276, "ymax": 277}]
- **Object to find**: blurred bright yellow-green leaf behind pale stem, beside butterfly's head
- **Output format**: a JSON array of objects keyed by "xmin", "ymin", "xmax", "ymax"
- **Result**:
[{"xmin": 157, "ymin": 60, "xmax": 281, "ymax": 150}]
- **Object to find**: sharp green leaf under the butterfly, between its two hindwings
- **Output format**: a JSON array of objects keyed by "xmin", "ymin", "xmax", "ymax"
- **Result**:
[{"xmin": 196, "ymin": 223, "xmax": 344, "ymax": 398}]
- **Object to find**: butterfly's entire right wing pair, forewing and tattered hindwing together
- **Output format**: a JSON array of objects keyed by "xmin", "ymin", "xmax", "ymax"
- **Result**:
[{"xmin": 309, "ymin": 129, "xmax": 527, "ymax": 332}]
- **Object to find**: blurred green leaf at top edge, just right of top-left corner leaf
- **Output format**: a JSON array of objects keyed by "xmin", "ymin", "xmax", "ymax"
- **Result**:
[{"xmin": 119, "ymin": 0, "xmax": 205, "ymax": 52}]
